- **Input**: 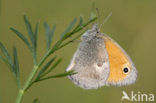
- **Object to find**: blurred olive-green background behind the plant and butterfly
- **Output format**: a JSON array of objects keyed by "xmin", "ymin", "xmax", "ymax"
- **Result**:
[{"xmin": 0, "ymin": 0, "xmax": 156, "ymax": 103}]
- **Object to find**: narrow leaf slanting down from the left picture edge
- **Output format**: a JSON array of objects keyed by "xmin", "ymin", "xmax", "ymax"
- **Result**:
[{"xmin": 0, "ymin": 42, "xmax": 14, "ymax": 72}]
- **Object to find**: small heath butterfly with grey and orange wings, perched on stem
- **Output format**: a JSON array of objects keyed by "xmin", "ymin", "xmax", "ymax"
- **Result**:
[{"xmin": 66, "ymin": 24, "xmax": 137, "ymax": 89}]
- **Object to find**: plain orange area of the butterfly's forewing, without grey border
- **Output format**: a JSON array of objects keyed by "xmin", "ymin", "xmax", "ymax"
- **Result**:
[{"xmin": 104, "ymin": 36, "xmax": 130, "ymax": 82}]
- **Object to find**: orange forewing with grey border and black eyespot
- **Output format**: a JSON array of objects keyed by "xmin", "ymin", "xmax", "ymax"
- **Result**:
[{"xmin": 104, "ymin": 35, "xmax": 137, "ymax": 86}]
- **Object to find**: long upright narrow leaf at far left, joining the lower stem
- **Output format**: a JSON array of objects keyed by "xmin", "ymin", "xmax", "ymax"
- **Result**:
[{"xmin": 13, "ymin": 46, "xmax": 21, "ymax": 88}]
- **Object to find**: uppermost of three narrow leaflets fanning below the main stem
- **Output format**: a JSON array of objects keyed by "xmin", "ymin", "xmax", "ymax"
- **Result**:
[{"xmin": 36, "ymin": 56, "xmax": 56, "ymax": 79}]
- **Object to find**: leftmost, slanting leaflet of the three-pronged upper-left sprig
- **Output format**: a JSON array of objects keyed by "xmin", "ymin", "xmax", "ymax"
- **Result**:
[{"xmin": 10, "ymin": 28, "xmax": 32, "ymax": 51}]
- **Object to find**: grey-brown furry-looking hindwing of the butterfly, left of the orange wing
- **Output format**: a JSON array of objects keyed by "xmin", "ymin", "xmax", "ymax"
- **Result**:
[{"xmin": 66, "ymin": 34, "xmax": 109, "ymax": 89}]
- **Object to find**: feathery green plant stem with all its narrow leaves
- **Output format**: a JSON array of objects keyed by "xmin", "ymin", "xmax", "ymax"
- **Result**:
[{"xmin": 0, "ymin": 11, "xmax": 96, "ymax": 103}]
